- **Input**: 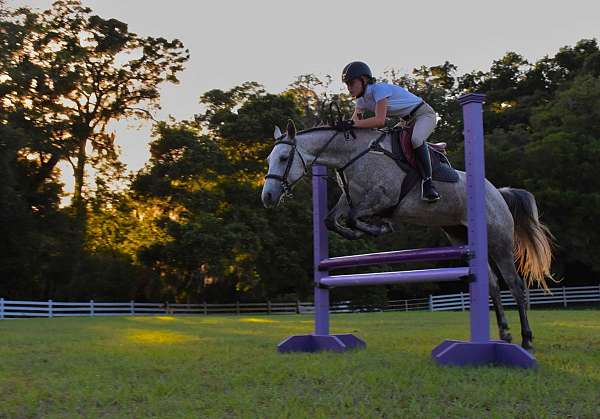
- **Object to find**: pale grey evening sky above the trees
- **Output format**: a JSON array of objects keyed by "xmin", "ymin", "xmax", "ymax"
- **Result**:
[{"xmin": 7, "ymin": 0, "xmax": 600, "ymax": 193}]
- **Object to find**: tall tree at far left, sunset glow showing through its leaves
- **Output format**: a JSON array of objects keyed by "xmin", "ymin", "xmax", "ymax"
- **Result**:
[{"xmin": 0, "ymin": 0, "xmax": 189, "ymax": 215}]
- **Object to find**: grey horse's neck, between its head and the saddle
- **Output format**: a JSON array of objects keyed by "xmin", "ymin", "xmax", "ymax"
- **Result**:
[{"xmin": 298, "ymin": 130, "xmax": 376, "ymax": 168}]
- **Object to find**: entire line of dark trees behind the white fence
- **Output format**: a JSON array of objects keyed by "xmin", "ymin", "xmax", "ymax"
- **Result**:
[{"xmin": 0, "ymin": 0, "xmax": 600, "ymax": 302}]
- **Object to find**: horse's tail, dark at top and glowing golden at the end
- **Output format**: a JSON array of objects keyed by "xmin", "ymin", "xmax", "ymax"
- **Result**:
[{"xmin": 499, "ymin": 188, "xmax": 554, "ymax": 290}]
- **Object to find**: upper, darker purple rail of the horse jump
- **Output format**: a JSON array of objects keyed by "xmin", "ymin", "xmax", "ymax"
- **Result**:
[{"xmin": 319, "ymin": 246, "xmax": 469, "ymax": 270}]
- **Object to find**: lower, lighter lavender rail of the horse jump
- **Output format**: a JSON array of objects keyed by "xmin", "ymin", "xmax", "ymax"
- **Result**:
[{"xmin": 319, "ymin": 267, "xmax": 470, "ymax": 287}]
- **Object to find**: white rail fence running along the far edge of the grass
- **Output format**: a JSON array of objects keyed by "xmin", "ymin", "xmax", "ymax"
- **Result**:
[{"xmin": 0, "ymin": 284, "xmax": 600, "ymax": 319}]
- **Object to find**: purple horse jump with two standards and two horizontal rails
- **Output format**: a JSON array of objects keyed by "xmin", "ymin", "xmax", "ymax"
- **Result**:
[{"xmin": 278, "ymin": 93, "xmax": 536, "ymax": 368}]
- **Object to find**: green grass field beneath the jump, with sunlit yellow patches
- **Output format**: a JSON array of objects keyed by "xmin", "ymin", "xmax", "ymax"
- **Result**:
[{"xmin": 0, "ymin": 310, "xmax": 600, "ymax": 418}]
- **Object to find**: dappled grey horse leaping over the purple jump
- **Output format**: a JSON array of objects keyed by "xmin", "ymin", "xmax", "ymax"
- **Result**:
[{"xmin": 261, "ymin": 121, "xmax": 554, "ymax": 350}]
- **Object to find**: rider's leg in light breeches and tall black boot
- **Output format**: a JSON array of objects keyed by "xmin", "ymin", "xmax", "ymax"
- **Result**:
[{"xmin": 411, "ymin": 103, "xmax": 440, "ymax": 202}]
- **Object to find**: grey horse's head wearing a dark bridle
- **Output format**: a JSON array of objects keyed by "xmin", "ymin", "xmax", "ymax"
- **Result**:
[{"xmin": 261, "ymin": 121, "xmax": 307, "ymax": 208}]
